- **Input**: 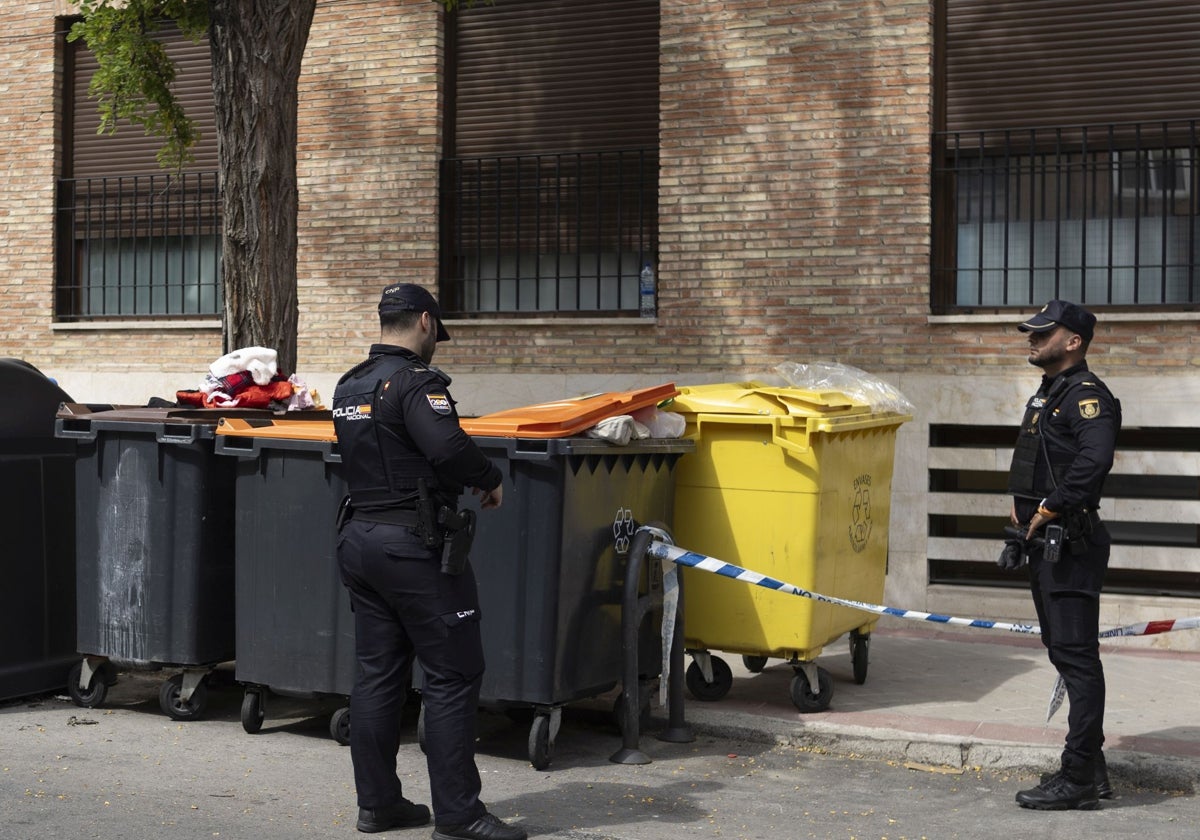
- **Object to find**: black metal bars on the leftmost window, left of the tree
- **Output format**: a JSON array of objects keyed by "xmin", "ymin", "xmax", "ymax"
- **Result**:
[{"xmin": 56, "ymin": 172, "xmax": 221, "ymax": 322}]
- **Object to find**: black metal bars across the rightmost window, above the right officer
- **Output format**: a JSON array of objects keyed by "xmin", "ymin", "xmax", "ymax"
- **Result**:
[{"xmin": 932, "ymin": 120, "xmax": 1200, "ymax": 311}]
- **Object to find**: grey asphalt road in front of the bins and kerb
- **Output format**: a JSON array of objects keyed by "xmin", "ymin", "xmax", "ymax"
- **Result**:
[{"xmin": 0, "ymin": 673, "xmax": 1200, "ymax": 840}]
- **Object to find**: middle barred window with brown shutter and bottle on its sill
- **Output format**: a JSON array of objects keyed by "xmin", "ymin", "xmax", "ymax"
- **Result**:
[{"xmin": 439, "ymin": 0, "xmax": 659, "ymax": 317}]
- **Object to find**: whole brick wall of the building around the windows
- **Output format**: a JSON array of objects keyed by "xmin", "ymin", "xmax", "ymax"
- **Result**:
[{"xmin": 0, "ymin": 0, "xmax": 1200, "ymax": 386}]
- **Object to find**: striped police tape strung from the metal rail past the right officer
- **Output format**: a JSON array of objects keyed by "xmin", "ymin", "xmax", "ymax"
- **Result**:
[{"xmin": 646, "ymin": 528, "xmax": 1200, "ymax": 722}]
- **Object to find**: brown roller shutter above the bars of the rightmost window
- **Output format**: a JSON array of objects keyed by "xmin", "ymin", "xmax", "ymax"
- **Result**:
[{"xmin": 944, "ymin": 0, "xmax": 1200, "ymax": 131}]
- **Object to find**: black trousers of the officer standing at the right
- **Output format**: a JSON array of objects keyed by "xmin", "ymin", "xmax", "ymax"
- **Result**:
[{"xmin": 1027, "ymin": 524, "xmax": 1109, "ymax": 784}]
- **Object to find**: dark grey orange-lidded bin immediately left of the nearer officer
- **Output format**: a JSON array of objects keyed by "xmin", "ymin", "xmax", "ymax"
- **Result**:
[{"xmin": 216, "ymin": 412, "xmax": 355, "ymax": 744}]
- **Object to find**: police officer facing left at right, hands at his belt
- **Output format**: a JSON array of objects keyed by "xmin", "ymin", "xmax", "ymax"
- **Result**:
[{"xmin": 1000, "ymin": 300, "xmax": 1121, "ymax": 810}]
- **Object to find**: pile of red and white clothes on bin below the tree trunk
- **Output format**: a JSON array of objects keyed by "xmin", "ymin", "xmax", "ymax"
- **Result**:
[{"xmin": 175, "ymin": 347, "xmax": 320, "ymax": 412}]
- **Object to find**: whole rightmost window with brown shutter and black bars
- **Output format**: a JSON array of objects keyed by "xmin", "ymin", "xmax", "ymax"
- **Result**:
[{"xmin": 931, "ymin": 0, "xmax": 1200, "ymax": 312}]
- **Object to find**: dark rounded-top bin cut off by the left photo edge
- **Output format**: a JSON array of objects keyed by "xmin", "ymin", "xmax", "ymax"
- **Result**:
[{"xmin": 0, "ymin": 359, "xmax": 76, "ymax": 700}]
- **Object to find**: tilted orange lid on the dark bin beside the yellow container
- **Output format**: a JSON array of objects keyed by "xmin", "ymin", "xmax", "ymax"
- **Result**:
[{"xmin": 462, "ymin": 383, "xmax": 679, "ymax": 438}]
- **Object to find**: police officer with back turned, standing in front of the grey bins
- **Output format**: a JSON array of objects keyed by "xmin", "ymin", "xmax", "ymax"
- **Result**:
[{"xmin": 334, "ymin": 283, "xmax": 526, "ymax": 840}]
